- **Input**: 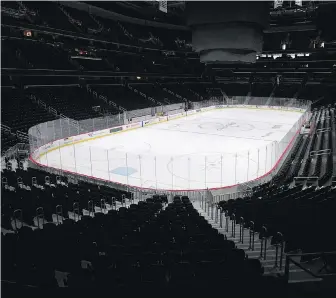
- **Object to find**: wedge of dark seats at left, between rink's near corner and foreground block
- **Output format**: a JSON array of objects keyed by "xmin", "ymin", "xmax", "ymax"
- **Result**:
[{"xmin": 1, "ymin": 168, "xmax": 133, "ymax": 229}]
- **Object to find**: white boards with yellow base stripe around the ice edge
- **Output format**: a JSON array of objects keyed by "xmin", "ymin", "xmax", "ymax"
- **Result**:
[{"xmin": 31, "ymin": 105, "xmax": 305, "ymax": 192}]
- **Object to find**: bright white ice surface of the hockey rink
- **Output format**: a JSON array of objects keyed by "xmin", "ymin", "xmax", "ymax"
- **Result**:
[{"xmin": 37, "ymin": 108, "xmax": 302, "ymax": 190}]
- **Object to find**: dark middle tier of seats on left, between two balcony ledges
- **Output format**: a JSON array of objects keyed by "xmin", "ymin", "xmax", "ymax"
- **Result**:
[{"xmin": 1, "ymin": 33, "xmax": 202, "ymax": 74}]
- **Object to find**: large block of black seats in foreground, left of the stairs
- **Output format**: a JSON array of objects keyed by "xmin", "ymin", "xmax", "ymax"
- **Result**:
[{"xmin": 2, "ymin": 196, "xmax": 288, "ymax": 297}]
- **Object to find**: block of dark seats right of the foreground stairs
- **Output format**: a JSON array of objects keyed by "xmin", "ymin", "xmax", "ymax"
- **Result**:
[{"xmin": 220, "ymin": 185, "xmax": 336, "ymax": 252}]
